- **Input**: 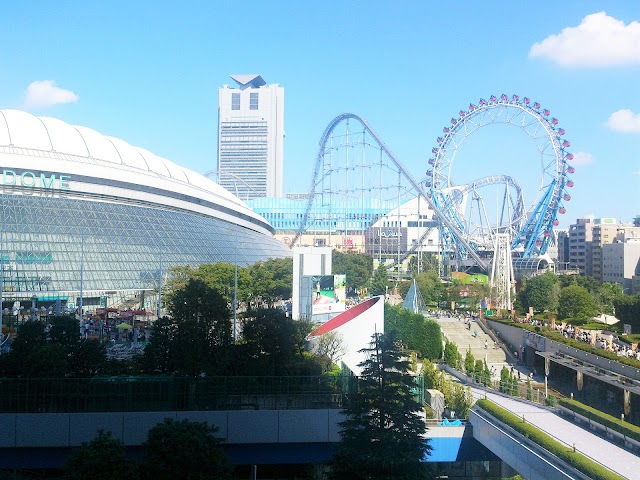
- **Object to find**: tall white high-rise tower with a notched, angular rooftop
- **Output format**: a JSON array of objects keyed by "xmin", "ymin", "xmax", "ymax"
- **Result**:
[{"xmin": 218, "ymin": 75, "xmax": 284, "ymax": 200}]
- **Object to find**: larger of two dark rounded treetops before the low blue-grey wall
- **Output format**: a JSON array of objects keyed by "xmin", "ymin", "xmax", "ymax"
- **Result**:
[{"xmin": 142, "ymin": 418, "xmax": 231, "ymax": 480}]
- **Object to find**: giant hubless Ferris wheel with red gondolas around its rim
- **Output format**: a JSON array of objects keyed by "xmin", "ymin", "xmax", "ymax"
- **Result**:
[{"xmin": 425, "ymin": 94, "xmax": 575, "ymax": 258}]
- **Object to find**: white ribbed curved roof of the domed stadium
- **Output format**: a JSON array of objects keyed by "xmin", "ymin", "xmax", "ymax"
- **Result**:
[{"xmin": 0, "ymin": 109, "xmax": 273, "ymax": 236}]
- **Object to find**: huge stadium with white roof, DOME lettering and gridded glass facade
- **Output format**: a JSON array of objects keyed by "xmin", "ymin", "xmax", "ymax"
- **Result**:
[{"xmin": 0, "ymin": 110, "xmax": 290, "ymax": 311}]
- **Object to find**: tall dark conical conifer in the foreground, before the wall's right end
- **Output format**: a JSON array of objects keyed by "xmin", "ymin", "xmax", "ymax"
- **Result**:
[{"xmin": 331, "ymin": 334, "xmax": 431, "ymax": 480}]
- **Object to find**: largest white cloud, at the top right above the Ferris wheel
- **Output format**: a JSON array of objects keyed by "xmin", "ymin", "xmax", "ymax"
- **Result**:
[{"xmin": 529, "ymin": 12, "xmax": 640, "ymax": 67}]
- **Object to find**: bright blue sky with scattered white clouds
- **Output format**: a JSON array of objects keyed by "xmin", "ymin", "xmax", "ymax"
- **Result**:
[{"xmin": 0, "ymin": 0, "xmax": 640, "ymax": 226}]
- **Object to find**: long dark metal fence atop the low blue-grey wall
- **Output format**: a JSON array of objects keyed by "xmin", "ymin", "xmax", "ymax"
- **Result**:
[{"xmin": 0, "ymin": 376, "xmax": 424, "ymax": 413}]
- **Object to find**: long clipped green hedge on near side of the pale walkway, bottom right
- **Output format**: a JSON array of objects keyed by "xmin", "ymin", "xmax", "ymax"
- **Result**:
[{"xmin": 476, "ymin": 399, "xmax": 624, "ymax": 480}]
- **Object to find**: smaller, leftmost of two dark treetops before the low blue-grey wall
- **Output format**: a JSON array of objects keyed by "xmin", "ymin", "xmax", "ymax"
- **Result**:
[{"xmin": 63, "ymin": 430, "xmax": 139, "ymax": 480}]
